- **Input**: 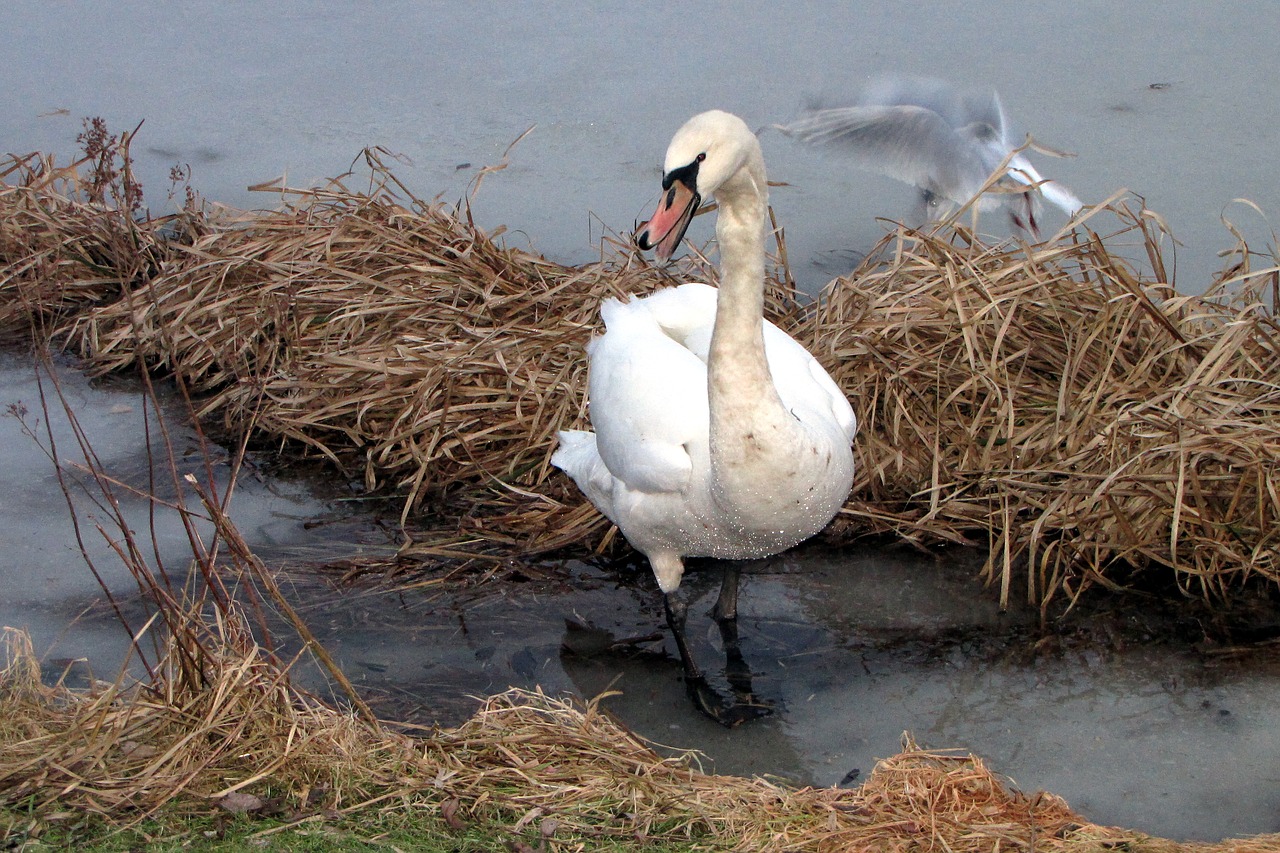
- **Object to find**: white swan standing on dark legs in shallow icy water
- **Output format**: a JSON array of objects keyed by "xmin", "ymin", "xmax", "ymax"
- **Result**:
[{"xmin": 552, "ymin": 110, "xmax": 856, "ymax": 721}]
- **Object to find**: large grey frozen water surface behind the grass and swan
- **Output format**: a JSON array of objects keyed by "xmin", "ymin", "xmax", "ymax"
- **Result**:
[{"xmin": 0, "ymin": 0, "xmax": 1280, "ymax": 291}]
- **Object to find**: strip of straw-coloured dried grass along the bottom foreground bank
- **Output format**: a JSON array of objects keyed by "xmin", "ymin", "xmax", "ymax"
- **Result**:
[{"xmin": 10, "ymin": 622, "xmax": 1280, "ymax": 853}]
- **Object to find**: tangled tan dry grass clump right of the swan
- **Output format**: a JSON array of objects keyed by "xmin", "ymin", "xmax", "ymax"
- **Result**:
[{"xmin": 796, "ymin": 205, "xmax": 1280, "ymax": 605}]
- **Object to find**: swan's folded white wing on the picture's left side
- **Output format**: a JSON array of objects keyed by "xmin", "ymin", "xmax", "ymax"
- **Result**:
[{"xmin": 589, "ymin": 300, "xmax": 709, "ymax": 492}]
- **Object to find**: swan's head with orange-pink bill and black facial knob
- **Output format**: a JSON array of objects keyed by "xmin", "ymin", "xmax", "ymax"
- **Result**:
[{"xmin": 636, "ymin": 110, "xmax": 765, "ymax": 260}]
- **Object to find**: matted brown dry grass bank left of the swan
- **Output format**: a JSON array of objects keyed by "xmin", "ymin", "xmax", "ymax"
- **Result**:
[{"xmin": 0, "ymin": 140, "xmax": 778, "ymax": 549}]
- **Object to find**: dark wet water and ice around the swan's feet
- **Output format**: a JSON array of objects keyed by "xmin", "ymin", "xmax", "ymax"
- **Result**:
[{"xmin": 285, "ymin": 547, "xmax": 1280, "ymax": 839}]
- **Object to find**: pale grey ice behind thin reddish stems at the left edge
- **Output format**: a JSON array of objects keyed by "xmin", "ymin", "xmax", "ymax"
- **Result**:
[{"xmin": 0, "ymin": 352, "xmax": 390, "ymax": 678}]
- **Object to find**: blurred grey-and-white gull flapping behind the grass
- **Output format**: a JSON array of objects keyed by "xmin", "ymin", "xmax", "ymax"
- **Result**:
[{"xmin": 776, "ymin": 77, "xmax": 1080, "ymax": 237}]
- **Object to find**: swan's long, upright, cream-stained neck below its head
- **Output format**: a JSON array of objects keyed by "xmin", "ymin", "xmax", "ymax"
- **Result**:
[{"xmin": 707, "ymin": 153, "xmax": 800, "ymax": 515}]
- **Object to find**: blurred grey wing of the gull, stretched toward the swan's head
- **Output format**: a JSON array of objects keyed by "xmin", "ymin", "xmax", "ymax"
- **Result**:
[{"xmin": 778, "ymin": 105, "xmax": 987, "ymax": 201}]
